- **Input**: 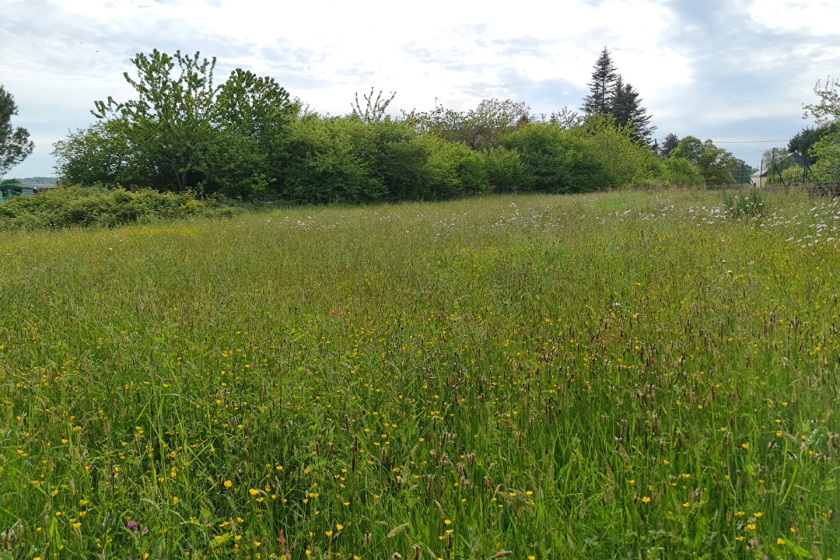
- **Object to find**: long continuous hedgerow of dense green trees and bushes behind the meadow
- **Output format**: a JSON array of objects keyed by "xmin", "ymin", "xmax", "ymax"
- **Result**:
[{"xmin": 49, "ymin": 50, "xmax": 696, "ymax": 204}]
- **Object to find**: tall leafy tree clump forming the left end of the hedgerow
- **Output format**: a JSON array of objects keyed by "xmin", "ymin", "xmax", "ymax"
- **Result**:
[{"xmin": 54, "ymin": 50, "xmax": 300, "ymax": 198}]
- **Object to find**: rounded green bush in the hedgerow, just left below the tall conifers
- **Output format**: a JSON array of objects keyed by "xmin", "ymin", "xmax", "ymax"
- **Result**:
[{"xmin": 502, "ymin": 123, "xmax": 616, "ymax": 193}]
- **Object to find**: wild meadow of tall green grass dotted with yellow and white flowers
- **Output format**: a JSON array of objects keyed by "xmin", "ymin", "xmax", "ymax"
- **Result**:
[{"xmin": 0, "ymin": 191, "xmax": 840, "ymax": 560}]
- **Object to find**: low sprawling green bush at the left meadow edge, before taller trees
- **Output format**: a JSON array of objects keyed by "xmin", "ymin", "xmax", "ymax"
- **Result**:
[{"xmin": 0, "ymin": 187, "xmax": 233, "ymax": 230}]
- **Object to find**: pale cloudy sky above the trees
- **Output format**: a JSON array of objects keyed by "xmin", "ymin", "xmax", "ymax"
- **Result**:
[{"xmin": 0, "ymin": 0, "xmax": 840, "ymax": 177}]
